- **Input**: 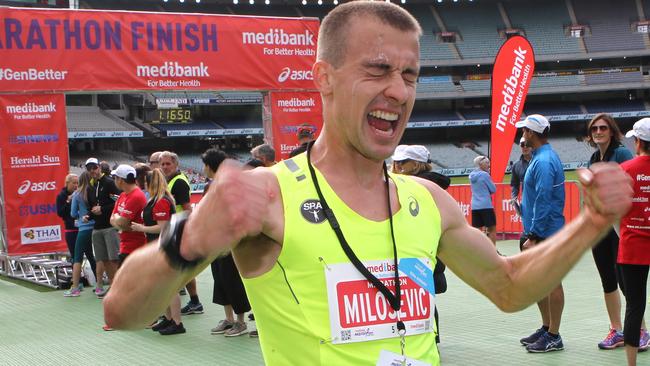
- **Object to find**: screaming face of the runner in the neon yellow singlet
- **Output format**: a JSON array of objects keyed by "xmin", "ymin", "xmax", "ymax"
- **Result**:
[{"xmin": 321, "ymin": 17, "xmax": 420, "ymax": 161}]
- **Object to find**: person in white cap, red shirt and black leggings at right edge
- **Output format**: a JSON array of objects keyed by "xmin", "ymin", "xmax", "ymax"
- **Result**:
[{"xmin": 617, "ymin": 118, "xmax": 650, "ymax": 365}]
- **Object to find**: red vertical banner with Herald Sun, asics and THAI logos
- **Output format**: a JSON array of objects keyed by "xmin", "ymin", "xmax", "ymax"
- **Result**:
[{"xmin": 0, "ymin": 94, "xmax": 70, "ymax": 255}]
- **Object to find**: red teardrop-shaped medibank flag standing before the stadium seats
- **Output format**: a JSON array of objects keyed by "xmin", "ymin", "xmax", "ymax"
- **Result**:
[{"xmin": 490, "ymin": 36, "xmax": 535, "ymax": 182}]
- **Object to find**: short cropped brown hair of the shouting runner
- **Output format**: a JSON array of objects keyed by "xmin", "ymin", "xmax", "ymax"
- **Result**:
[{"xmin": 316, "ymin": 1, "xmax": 422, "ymax": 67}]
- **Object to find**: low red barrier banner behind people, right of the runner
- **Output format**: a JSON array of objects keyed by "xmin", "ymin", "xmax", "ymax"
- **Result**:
[{"xmin": 447, "ymin": 182, "xmax": 581, "ymax": 234}]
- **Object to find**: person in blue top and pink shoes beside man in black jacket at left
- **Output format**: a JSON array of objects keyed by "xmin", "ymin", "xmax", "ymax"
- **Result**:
[{"xmin": 63, "ymin": 172, "xmax": 95, "ymax": 297}]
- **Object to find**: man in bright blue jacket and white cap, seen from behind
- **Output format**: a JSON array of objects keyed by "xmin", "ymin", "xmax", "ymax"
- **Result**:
[{"xmin": 516, "ymin": 114, "xmax": 564, "ymax": 352}]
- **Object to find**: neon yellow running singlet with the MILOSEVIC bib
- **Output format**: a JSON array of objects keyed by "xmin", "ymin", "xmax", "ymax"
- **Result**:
[{"xmin": 243, "ymin": 154, "xmax": 441, "ymax": 365}]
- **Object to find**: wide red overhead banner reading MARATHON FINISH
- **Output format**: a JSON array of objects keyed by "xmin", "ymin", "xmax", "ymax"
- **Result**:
[{"xmin": 0, "ymin": 7, "xmax": 319, "ymax": 92}]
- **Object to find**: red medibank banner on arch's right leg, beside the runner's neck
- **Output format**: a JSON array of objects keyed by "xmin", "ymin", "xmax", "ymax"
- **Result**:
[{"xmin": 270, "ymin": 92, "xmax": 323, "ymax": 161}]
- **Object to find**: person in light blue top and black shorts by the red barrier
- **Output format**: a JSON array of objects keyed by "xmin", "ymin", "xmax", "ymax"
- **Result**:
[{"xmin": 469, "ymin": 155, "xmax": 497, "ymax": 247}]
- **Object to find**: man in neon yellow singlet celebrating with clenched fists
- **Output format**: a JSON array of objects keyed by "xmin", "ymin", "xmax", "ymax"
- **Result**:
[{"xmin": 104, "ymin": 1, "xmax": 631, "ymax": 365}]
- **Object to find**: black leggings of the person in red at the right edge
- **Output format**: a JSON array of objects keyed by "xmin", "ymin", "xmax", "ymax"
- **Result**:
[{"xmin": 619, "ymin": 264, "xmax": 650, "ymax": 347}]
